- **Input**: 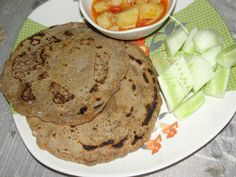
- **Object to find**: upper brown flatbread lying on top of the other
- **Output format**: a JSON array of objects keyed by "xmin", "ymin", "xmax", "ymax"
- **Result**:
[{"xmin": 2, "ymin": 23, "xmax": 128, "ymax": 125}]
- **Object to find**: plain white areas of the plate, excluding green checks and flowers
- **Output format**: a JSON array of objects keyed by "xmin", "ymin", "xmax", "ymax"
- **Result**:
[{"xmin": 14, "ymin": 0, "xmax": 236, "ymax": 177}]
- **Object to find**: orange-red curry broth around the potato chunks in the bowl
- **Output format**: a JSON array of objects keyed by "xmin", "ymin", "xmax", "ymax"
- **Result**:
[{"xmin": 91, "ymin": 0, "xmax": 168, "ymax": 31}]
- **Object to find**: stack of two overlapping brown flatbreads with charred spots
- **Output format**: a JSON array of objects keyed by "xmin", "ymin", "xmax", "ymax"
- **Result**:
[{"xmin": 2, "ymin": 23, "xmax": 161, "ymax": 165}]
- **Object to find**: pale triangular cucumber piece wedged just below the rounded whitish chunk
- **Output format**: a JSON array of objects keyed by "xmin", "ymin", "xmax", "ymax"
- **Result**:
[{"xmin": 201, "ymin": 45, "xmax": 222, "ymax": 70}]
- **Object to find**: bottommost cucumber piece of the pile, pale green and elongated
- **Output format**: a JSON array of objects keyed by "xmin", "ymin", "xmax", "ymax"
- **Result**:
[{"xmin": 173, "ymin": 91, "xmax": 205, "ymax": 120}]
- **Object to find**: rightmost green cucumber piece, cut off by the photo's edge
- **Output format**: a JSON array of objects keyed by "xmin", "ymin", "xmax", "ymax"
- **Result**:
[{"xmin": 217, "ymin": 44, "xmax": 236, "ymax": 68}]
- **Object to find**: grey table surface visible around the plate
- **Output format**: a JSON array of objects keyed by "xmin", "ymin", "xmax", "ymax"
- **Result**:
[{"xmin": 0, "ymin": 0, "xmax": 236, "ymax": 177}]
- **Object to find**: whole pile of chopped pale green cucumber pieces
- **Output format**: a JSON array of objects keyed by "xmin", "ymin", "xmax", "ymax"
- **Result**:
[{"xmin": 154, "ymin": 26, "xmax": 236, "ymax": 119}]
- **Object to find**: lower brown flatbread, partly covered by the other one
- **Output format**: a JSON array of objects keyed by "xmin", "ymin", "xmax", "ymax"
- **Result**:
[{"xmin": 27, "ymin": 44, "xmax": 161, "ymax": 165}]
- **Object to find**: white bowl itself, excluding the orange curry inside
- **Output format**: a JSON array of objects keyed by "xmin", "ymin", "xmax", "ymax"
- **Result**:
[{"xmin": 79, "ymin": 0, "xmax": 177, "ymax": 40}]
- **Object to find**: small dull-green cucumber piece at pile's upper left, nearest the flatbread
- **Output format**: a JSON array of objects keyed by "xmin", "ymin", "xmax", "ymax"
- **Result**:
[{"xmin": 152, "ymin": 56, "xmax": 171, "ymax": 75}]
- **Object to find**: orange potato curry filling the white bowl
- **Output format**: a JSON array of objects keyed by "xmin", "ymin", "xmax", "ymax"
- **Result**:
[{"xmin": 91, "ymin": 0, "xmax": 168, "ymax": 31}]
